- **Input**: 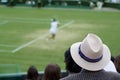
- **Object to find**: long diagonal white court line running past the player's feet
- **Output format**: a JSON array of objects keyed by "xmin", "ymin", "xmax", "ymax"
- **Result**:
[{"xmin": 12, "ymin": 20, "xmax": 74, "ymax": 53}]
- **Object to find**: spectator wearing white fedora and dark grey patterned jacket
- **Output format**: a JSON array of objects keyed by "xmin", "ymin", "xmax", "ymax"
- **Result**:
[{"xmin": 61, "ymin": 34, "xmax": 120, "ymax": 80}]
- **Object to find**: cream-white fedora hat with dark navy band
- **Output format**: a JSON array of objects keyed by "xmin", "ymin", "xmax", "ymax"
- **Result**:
[{"xmin": 70, "ymin": 33, "xmax": 111, "ymax": 71}]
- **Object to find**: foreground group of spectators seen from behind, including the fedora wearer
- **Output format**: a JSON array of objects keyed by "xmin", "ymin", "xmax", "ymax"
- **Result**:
[{"xmin": 26, "ymin": 33, "xmax": 120, "ymax": 80}]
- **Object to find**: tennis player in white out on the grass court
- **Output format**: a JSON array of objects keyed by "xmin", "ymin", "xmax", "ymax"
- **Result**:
[{"xmin": 50, "ymin": 18, "xmax": 59, "ymax": 40}]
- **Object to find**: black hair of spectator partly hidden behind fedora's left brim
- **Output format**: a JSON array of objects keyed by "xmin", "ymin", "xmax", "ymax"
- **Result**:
[{"xmin": 64, "ymin": 48, "xmax": 82, "ymax": 73}]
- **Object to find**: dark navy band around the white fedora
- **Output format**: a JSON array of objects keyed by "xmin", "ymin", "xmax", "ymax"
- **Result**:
[{"xmin": 78, "ymin": 45, "xmax": 103, "ymax": 63}]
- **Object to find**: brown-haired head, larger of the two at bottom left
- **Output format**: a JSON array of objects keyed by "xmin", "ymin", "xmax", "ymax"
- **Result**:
[{"xmin": 43, "ymin": 63, "xmax": 61, "ymax": 80}]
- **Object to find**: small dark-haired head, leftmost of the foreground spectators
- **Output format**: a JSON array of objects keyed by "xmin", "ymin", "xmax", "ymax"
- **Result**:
[{"xmin": 27, "ymin": 66, "xmax": 39, "ymax": 80}]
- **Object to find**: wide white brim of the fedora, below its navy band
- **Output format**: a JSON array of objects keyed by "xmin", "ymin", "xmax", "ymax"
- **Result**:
[{"xmin": 70, "ymin": 42, "xmax": 111, "ymax": 71}]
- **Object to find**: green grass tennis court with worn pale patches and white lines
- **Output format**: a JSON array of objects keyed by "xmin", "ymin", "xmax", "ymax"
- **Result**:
[{"xmin": 0, "ymin": 7, "xmax": 120, "ymax": 72}]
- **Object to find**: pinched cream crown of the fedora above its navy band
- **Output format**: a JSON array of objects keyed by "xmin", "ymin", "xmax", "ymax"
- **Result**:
[{"xmin": 81, "ymin": 34, "xmax": 103, "ymax": 59}]
